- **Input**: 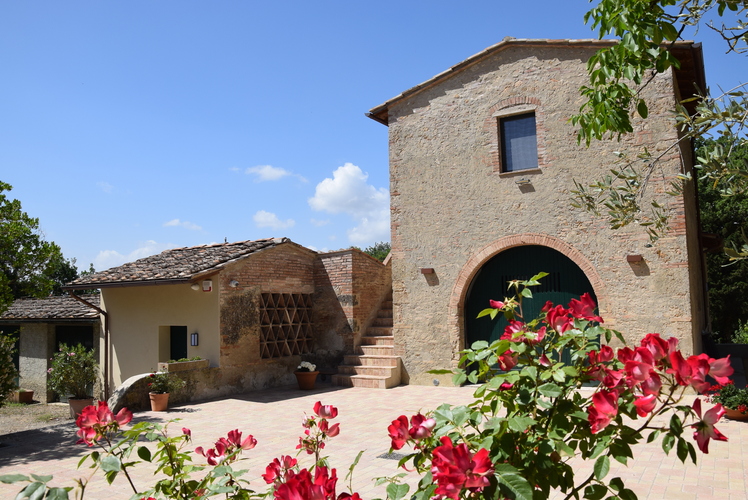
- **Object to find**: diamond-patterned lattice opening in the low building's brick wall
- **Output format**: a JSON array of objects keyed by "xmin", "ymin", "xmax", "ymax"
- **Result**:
[{"xmin": 260, "ymin": 293, "xmax": 312, "ymax": 358}]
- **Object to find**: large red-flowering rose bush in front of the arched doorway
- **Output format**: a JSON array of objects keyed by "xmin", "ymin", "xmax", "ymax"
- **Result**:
[{"xmin": 389, "ymin": 273, "xmax": 732, "ymax": 500}]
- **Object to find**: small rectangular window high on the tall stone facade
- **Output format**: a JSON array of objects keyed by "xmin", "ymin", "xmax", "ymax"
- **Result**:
[{"xmin": 499, "ymin": 113, "xmax": 538, "ymax": 172}]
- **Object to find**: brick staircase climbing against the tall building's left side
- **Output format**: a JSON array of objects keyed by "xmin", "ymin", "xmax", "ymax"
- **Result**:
[{"xmin": 332, "ymin": 296, "xmax": 400, "ymax": 389}]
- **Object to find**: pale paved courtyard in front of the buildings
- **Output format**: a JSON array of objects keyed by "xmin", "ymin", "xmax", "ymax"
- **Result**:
[{"xmin": 0, "ymin": 385, "xmax": 748, "ymax": 500}]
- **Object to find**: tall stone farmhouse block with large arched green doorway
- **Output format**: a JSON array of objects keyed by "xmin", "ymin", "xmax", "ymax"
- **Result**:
[{"xmin": 368, "ymin": 38, "xmax": 707, "ymax": 384}]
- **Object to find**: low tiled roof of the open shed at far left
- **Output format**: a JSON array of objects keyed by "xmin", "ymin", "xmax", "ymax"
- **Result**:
[{"xmin": 0, "ymin": 294, "xmax": 101, "ymax": 323}]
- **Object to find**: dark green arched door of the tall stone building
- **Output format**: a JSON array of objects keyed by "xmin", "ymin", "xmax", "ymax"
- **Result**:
[{"xmin": 464, "ymin": 245, "xmax": 597, "ymax": 347}]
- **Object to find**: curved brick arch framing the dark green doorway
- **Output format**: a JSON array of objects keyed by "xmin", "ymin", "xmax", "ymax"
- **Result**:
[{"xmin": 448, "ymin": 233, "xmax": 610, "ymax": 356}]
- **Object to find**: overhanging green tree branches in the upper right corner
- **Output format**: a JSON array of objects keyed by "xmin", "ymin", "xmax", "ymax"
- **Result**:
[{"xmin": 571, "ymin": 0, "xmax": 748, "ymax": 248}]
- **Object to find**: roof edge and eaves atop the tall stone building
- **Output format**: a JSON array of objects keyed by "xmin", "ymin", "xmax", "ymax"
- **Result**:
[{"xmin": 366, "ymin": 37, "xmax": 706, "ymax": 125}]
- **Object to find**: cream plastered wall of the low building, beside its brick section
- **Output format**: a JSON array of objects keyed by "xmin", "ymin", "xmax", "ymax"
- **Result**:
[{"xmin": 101, "ymin": 279, "xmax": 220, "ymax": 387}]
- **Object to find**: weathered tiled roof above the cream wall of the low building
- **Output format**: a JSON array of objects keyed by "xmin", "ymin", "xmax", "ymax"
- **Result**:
[{"xmin": 63, "ymin": 238, "xmax": 298, "ymax": 290}]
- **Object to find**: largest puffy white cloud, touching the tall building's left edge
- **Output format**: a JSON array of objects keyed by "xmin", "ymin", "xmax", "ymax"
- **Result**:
[{"xmin": 309, "ymin": 163, "xmax": 390, "ymax": 245}]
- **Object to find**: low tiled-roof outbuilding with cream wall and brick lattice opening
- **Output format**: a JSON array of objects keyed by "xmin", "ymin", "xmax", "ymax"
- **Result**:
[{"xmin": 57, "ymin": 238, "xmax": 392, "ymax": 400}]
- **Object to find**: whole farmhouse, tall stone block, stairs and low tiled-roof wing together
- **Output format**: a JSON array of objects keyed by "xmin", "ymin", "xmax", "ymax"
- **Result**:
[{"xmin": 2, "ymin": 38, "xmax": 708, "ymax": 400}]
